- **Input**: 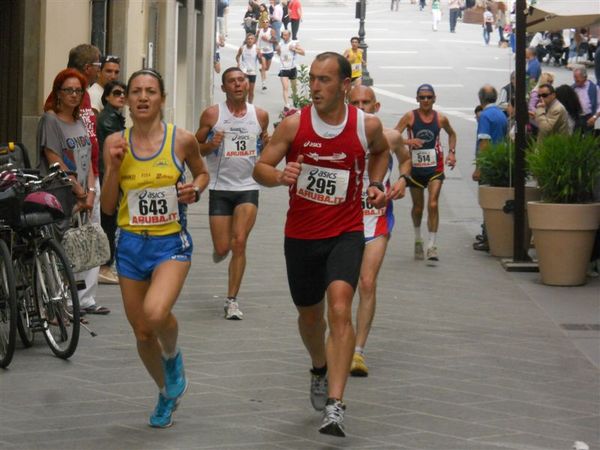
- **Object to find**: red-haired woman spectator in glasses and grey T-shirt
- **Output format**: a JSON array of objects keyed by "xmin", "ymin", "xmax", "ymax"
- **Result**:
[{"xmin": 37, "ymin": 69, "xmax": 110, "ymax": 314}]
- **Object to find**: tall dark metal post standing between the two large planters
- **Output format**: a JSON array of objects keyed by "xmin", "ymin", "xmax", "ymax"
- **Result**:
[{"xmin": 513, "ymin": 0, "xmax": 529, "ymax": 262}]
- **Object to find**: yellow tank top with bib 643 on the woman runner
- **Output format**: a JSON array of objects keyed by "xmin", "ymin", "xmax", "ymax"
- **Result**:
[{"xmin": 117, "ymin": 123, "xmax": 185, "ymax": 236}]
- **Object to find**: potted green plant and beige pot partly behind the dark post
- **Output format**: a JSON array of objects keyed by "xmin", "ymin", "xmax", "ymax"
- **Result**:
[{"xmin": 477, "ymin": 141, "xmax": 539, "ymax": 258}]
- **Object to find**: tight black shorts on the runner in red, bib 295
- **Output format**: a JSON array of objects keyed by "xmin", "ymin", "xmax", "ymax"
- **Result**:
[{"xmin": 284, "ymin": 231, "xmax": 365, "ymax": 306}]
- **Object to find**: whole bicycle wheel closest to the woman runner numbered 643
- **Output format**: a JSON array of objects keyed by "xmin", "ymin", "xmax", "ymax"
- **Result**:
[{"xmin": 34, "ymin": 239, "xmax": 80, "ymax": 359}]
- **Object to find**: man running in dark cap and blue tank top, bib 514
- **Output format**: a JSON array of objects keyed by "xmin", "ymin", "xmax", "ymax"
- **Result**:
[{"xmin": 396, "ymin": 84, "xmax": 456, "ymax": 266}]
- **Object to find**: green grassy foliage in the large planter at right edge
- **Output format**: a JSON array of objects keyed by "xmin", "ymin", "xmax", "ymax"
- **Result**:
[{"xmin": 527, "ymin": 133, "xmax": 600, "ymax": 203}]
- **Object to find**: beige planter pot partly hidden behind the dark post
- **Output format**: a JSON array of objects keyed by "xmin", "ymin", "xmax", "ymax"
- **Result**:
[{"xmin": 479, "ymin": 185, "xmax": 540, "ymax": 258}]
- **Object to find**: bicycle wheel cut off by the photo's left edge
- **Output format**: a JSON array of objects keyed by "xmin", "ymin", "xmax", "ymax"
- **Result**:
[{"xmin": 0, "ymin": 240, "xmax": 17, "ymax": 368}]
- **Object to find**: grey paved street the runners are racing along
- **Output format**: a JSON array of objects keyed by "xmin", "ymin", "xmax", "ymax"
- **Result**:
[{"xmin": 0, "ymin": 1, "xmax": 600, "ymax": 450}]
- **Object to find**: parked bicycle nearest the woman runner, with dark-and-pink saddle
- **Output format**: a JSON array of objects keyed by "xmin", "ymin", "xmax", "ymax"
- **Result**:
[{"xmin": 0, "ymin": 165, "xmax": 80, "ymax": 359}]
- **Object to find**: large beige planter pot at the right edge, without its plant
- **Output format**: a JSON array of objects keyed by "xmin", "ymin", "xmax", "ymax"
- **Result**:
[{"xmin": 527, "ymin": 202, "xmax": 600, "ymax": 286}]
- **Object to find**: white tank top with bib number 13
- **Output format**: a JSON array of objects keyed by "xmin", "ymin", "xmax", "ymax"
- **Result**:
[{"xmin": 206, "ymin": 102, "xmax": 262, "ymax": 191}]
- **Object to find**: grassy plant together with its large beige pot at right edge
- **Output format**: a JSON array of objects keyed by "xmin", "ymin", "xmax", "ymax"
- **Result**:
[{"xmin": 527, "ymin": 133, "xmax": 600, "ymax": 286}]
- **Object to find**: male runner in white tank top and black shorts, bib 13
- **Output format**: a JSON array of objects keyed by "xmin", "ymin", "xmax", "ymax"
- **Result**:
[{"xmin": 196, "ymin": 67, "xmax": 269, "ymax": 320}]
